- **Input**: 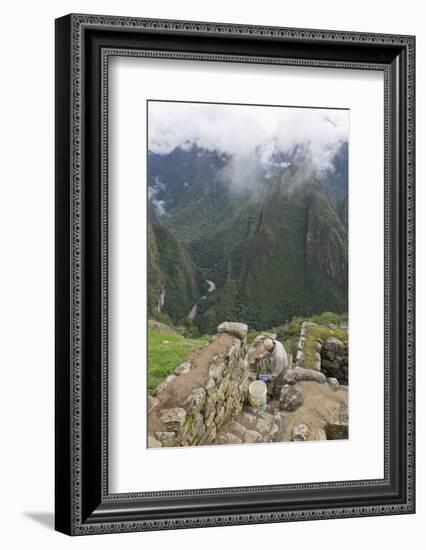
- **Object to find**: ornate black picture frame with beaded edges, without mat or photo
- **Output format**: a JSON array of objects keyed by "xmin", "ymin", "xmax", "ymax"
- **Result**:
[{"xmin": 56, "ymin": 15, "xmax": 415, "ymax": 535}]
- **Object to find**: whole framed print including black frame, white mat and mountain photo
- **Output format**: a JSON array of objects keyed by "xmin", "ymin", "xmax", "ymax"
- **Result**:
[{"xmin": 56, "ymin": 15, "xmax": 415, "ymax": 535}]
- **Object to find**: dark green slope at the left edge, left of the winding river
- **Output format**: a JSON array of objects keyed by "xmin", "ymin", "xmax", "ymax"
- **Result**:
[{"xmin": 148, "ymin": 223, "xmax": 206, "ymax": 321}]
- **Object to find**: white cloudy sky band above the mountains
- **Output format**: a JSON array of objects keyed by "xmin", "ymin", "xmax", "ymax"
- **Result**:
[{"xmin": 148, "ymin": 101, "xmax": 349, "ymax": 175}]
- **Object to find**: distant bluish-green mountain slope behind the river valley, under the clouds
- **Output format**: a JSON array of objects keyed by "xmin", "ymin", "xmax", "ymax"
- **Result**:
[{"xmin": 149, "ymin": 146, "xmax": 265, "ymax": 288}]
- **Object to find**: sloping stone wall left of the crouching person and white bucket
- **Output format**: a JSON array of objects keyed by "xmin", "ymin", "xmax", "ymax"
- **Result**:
[{"xmin": 148, "ymin": 323, "xmax": 249, "ymax": 447}]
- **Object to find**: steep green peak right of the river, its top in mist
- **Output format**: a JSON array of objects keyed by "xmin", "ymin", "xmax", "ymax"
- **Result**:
[{"xmin": 198, "ymin": 166, "xmax": 347, "ymax": 329}]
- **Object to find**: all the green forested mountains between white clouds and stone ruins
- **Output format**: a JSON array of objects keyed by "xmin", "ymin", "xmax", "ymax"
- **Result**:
[{"xmin": 148, "ymin": 147, "xmax": 348, "ymax": 333}]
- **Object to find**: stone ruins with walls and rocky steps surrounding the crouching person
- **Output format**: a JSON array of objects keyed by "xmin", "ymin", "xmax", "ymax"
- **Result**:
[{"xmin": 148, "ymin": 322, "xmax": 348, "ymax": 448}]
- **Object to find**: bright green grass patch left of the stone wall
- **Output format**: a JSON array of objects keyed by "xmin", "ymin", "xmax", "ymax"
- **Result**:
[{"xmin": 148, "ymin": 331, "xmax": 208, "ymax": 394}]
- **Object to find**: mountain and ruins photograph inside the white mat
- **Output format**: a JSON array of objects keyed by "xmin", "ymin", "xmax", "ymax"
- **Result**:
[{"xmin": 146, "ymin": 99, "xmax": 350, "ymax": 449}]
